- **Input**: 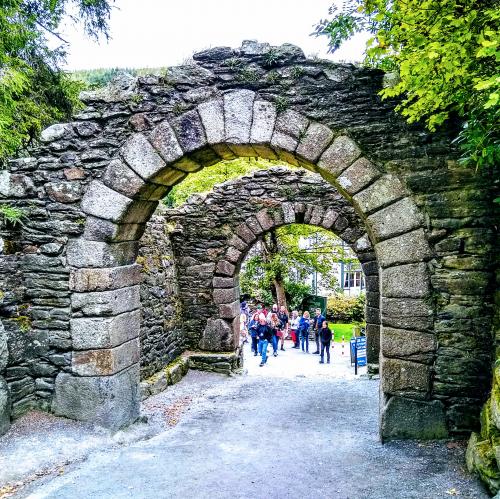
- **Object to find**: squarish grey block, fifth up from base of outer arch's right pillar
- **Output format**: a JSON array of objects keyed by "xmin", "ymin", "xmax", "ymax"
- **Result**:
[{"xmin": 380, "ymin": 263, "xmax": 430, "ymax": 298}]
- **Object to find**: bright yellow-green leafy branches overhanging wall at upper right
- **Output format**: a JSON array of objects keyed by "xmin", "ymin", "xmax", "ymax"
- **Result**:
[{"xmin": 315, "ymin": 0, "xmax": 500, "ymax": 178}]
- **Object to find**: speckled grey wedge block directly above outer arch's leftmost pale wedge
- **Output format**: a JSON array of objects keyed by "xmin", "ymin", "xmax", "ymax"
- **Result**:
[{"xmin": 102, "ymin": 159, "xmax": 167, "ymax": 201}]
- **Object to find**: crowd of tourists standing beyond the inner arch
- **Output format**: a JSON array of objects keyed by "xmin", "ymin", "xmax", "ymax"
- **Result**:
[{"xmin": 240, "ymin": 302, "xmax": 333, "ymax": 367}]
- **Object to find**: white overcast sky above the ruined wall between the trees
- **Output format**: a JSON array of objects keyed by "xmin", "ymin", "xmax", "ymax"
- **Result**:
[{"xmin": 61, "ymin": 0, "xmax": 367, "ymax": 70}]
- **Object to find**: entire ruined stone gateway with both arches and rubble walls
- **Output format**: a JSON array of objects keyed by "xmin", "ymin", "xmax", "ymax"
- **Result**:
[{"xmin": 0, "ymin": 42, "xmax": 498, "ymax": 446}]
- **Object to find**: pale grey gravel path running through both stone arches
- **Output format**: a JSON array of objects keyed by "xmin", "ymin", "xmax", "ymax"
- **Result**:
[{"xmin": 0, "ymin": 344, "xmax": 488, "ymax": 499}]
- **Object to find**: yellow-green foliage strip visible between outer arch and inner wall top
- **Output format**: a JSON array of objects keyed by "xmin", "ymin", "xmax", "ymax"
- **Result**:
[{"xmin": 163, "ymin": 158, "xmax": 274, "ymax": 207}]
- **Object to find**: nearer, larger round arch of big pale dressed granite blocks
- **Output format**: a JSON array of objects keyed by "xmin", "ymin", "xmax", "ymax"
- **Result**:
[{"xmin": 54, "ymin": 90, "xmax": 438, "ymax": 438}]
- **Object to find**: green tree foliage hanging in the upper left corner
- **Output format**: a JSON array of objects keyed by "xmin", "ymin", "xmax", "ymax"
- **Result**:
[{"xmin": 0, "ymin": 0, "xmax": 111, "ymax": 162}]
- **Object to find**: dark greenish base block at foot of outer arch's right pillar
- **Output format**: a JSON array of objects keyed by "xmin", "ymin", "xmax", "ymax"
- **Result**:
[{"xmin": 380, "ymin": 396, "xmax": 448, "ymax": 441}]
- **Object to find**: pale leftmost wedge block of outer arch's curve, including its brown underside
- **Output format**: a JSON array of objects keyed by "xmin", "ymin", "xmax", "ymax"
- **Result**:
[{"xmin": 82, "ymin": 180, "xmax": 158, "ymax": 223}]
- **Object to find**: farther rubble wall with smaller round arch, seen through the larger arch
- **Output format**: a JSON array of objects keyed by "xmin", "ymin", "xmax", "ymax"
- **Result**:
[{"xmin": 162, "ymin": 168, "xmax": 380, "ymax": 356}]
